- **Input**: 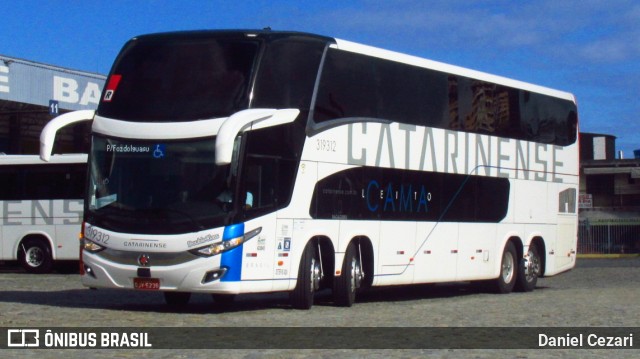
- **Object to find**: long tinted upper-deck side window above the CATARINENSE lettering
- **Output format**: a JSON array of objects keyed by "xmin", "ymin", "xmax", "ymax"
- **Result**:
[{"xmin": 312, "ymin": 49, "xmax": 578, "ymax": 146}]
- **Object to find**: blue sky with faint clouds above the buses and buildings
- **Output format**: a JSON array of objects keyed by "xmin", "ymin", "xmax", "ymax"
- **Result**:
[{"xmin": 0, "ymin": 0, "xmax": 640, "ymax": 158}]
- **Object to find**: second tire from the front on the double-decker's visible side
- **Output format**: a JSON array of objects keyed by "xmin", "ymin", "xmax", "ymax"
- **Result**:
[{"xmin": 333, "ymin": 242, "xmax": 362, "ymax": 307}]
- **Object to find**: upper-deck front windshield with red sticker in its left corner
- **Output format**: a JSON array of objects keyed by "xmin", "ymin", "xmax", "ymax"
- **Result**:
[{"xmin": 98, "ymin": 35, "xmax": 259, "ymax": 122}]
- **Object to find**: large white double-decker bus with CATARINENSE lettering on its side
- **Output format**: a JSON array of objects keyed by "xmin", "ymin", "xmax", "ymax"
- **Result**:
[{"xmin": 41, "ymin": 31, "xmax": 578, "ymax": 308}]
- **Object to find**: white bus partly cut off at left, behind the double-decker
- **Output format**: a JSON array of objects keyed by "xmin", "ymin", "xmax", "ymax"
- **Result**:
[{"xmin": 0, "ymin": 154, "xmax": 87, "ymax": 273}]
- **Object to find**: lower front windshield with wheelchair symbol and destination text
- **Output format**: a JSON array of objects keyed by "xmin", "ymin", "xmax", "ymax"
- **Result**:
[{"xmin": 86, "ymin": 136, "xmax": 234, "ymax": 234}]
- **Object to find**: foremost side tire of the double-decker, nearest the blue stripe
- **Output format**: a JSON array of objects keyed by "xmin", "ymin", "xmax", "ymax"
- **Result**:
[{"xmin": 289, "ymin": 242, "xmax": 321, "ymax": 309}]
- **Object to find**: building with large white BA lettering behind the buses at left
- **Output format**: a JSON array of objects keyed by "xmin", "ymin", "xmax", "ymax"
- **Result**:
[{"xmin": 0, "ymin": 55, "xmax": 106, "ymax": 154}]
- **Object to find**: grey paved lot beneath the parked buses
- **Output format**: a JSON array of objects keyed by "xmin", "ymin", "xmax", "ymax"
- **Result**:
[{"xmin": 0, "ymin": 257, "xmax": 640, "ymax": 358}]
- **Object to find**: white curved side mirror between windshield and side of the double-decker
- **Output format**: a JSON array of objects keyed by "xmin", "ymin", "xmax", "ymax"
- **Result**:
[{"xmin": 216, "ymin": 108, "xmax": 300, "ymax": 166}]
